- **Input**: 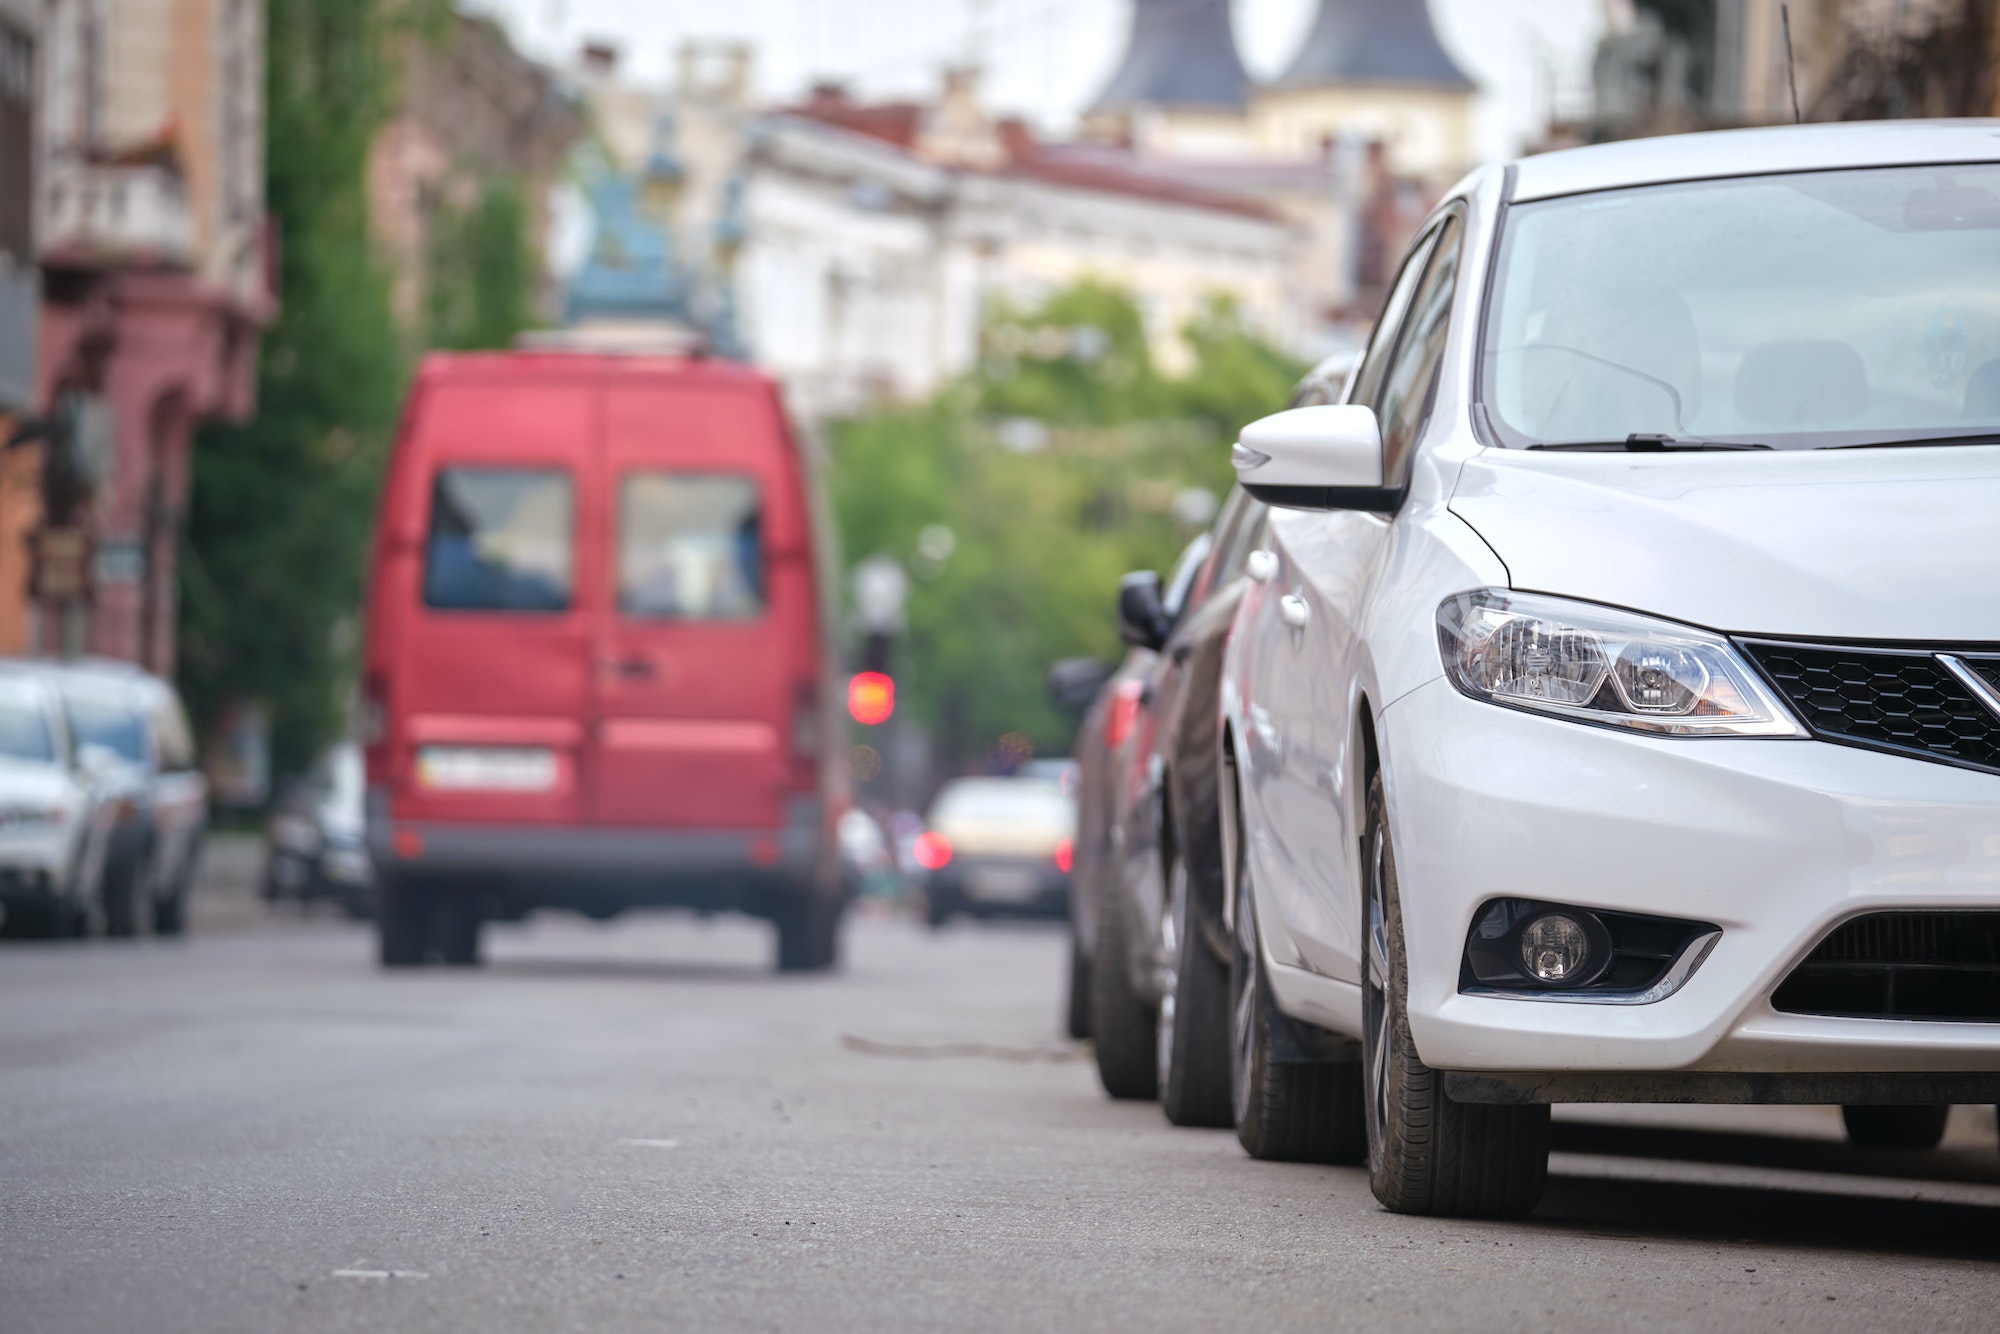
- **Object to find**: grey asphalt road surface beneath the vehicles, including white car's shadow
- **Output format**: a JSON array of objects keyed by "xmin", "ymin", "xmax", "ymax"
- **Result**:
[{"xmin": 0, "ymin": 840, "xmax": 2000, "ymax": 1334}]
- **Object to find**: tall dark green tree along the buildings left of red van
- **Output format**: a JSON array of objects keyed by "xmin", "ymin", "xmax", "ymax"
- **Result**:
[{"xmin": 180, "ymin": 0, "xmax": 444, "ymax": 788}]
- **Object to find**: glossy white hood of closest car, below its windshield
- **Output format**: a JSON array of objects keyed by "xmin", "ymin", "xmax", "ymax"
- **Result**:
[{"xmin": 1450, "ymin": 446, "xmax": 2000, "ymax": 644}]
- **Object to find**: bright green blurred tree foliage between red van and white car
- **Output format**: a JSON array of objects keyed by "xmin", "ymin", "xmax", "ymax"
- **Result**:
[{"xmin": 830, "ymin": 282, "xmax": 1302, "ymax": 768}]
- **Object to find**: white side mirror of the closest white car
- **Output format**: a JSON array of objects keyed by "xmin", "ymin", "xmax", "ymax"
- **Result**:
[{"xmin": 1230, "ymin": 404, "xmax": 1406, "ymax": 514}]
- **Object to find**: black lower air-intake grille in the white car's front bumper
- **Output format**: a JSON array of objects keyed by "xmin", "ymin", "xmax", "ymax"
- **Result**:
[{"xmin": 1770, "ymin": 912, "xmax": 2000, "ymax": 1020}]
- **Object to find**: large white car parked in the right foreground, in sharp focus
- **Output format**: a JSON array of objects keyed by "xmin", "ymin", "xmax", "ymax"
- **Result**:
[{"xmin": 1220, "ymin": 122, "xmax": 2000, "ymax": 1216}]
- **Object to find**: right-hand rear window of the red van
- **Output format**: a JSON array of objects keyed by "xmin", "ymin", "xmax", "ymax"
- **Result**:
[{"xmin": 618, "ymin": 472, "xmax": 764, "ymax": 620}]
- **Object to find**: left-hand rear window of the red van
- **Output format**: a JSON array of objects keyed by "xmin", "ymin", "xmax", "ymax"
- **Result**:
[{"xmin": 424, "ymin": 468, "xmax": 576, "ymax": 612}]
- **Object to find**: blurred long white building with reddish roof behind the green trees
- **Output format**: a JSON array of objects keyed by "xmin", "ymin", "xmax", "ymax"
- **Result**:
[{"xmin": 736, "ymin": 98, "xmax": 1312, "ymax": 416}]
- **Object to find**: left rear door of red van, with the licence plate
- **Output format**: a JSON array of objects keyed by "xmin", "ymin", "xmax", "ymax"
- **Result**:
[{"xmin": 378, "ymin": 378, "xmax": 596, "ymax": 824}]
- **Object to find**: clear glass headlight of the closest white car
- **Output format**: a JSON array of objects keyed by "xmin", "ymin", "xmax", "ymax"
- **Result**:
[{"xmin": 1438, "ymin": 588, "xmax": 1806, "ymax": 736}]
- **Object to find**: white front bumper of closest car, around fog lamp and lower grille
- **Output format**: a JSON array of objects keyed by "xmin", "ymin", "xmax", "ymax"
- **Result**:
[{"xmin": 1382, "ymin": 680, "xmax": 2000, "ymax": 1074}]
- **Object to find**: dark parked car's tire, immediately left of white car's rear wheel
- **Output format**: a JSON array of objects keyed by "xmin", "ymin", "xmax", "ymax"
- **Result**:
[{"xmin": 1154, "ymin": 856, "xmax": 1236, "ymax": 1128}]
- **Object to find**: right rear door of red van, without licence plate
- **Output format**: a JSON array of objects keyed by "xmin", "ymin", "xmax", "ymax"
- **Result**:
[{"xmin": 594, "ymin": 376, "xmax": 810, "ymax": 828}]
